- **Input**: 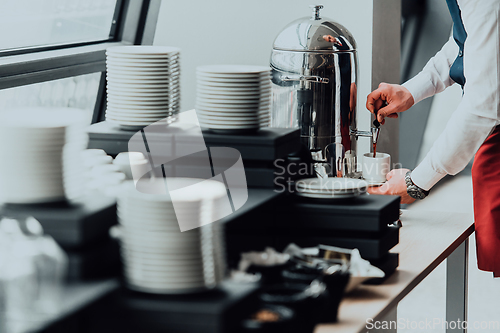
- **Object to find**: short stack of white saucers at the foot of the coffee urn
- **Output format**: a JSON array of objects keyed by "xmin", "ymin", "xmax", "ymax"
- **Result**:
[{"xmin": 295, "ymin": 178, "xmax": 368, "ymax": 199}]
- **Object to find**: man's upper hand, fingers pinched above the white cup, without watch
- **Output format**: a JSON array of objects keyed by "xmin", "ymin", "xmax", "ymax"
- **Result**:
[{"xmin": 366, "ymin": 83, "xmax": 415, "ymax": 124}]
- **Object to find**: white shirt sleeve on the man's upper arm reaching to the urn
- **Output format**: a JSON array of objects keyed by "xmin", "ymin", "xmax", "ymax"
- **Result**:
[{"xmin": 403, "ymin": 37, "xmax": 458, "ymax": 104}]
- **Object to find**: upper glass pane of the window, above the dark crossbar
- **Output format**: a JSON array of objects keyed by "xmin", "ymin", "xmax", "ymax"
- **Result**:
[{"xmin": 0, "ymin": 0, "xmax": 117, "ymax": 50}]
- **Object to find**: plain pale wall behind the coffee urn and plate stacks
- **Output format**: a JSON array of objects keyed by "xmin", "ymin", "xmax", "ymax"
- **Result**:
[{"xmin": 154, "ymin": 0, "xmax": 392, "ymax": 153}]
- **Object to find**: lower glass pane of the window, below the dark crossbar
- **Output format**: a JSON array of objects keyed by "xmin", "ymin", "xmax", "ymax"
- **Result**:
[{"xmin": 0, "ymin": 73, "xmax": 101, "ymax": 124}]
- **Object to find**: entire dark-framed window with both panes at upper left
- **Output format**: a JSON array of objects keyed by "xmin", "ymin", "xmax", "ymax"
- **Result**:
[{"xmin": 0, "ymin": 0, "xmax": 161, "ymax": 123}]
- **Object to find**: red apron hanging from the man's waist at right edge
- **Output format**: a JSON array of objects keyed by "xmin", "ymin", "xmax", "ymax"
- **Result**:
[{"xmin": 472, "ymin": 126, "xmax": 500, "ymax": 276}]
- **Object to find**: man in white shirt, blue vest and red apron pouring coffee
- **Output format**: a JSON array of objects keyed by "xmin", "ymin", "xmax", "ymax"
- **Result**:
[{"xmin": 366, "ymin": 0, "xmax": 500, "ymax": 277}]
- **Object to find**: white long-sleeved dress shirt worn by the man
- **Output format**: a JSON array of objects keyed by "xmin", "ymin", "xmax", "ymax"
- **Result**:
[{"xmin": 403, "ymin": 0, "xmax": 500, "ymax": 190}]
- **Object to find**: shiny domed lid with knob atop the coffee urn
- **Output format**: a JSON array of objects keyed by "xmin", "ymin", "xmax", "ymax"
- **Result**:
[{"xmin": 273, "ymin": 5, "xmax": 356, "ymax": 52}]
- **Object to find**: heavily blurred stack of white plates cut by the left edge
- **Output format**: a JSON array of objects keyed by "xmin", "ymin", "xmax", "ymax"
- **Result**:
[{"xmin": 0, "ymin": 108, "xmax": 86, "ymax": 203}]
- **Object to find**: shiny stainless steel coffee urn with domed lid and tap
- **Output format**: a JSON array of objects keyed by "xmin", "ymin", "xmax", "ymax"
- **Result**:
[{"xmin": 271, "ymin": 5, "xmax": 378, "ymax": 177}]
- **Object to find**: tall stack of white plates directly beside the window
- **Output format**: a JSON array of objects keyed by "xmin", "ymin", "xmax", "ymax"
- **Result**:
[{"xmin": 106, "ymin": 45, "xmax": 180, "ymax": 129}]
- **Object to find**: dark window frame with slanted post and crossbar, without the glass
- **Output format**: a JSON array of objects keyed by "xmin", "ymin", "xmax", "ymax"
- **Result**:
[{"xmin": 0, "ymin": 0, "xmax": 161, "ymax": 123}]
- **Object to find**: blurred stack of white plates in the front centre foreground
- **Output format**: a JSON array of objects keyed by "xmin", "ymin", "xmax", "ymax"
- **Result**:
[{"xmin": 118, "ymin": 178, "xmax": 227, "ymax": 294}]
